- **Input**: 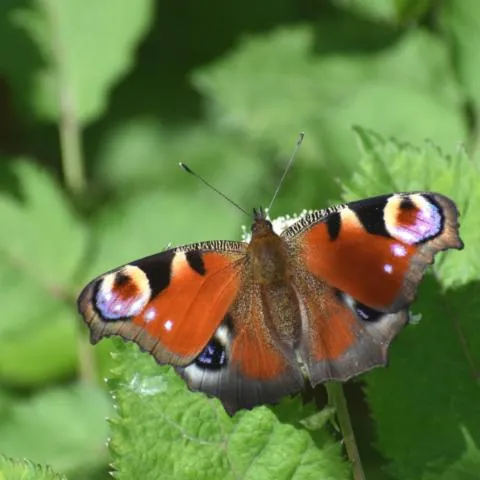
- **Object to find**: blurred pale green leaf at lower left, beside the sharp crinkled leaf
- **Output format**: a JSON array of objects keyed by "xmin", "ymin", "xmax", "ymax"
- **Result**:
[{"xmin": 0, "ymin": 386, "xmax": 111, "ymax": 478}]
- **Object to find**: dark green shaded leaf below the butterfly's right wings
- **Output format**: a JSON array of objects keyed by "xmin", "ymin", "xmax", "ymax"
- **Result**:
[{"xmin": 364, "ymin": 276, "xmax": 480, "ymax": 480}]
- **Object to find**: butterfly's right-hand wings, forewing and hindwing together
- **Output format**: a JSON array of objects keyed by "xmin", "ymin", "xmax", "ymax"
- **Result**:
[{"xmin": 282, "ymin": 193, "xmax": 462, "ymax": 384}]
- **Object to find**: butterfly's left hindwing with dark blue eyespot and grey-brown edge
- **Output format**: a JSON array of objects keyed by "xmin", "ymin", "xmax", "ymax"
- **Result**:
[{"xmin": 177, "ymin": 284, "xmax": 305, "ymax": 414}]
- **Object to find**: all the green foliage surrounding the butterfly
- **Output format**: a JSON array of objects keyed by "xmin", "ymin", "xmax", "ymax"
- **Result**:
[{"xmin": 0, "ymin": 0, "xmax": 480, "ymax": 480}]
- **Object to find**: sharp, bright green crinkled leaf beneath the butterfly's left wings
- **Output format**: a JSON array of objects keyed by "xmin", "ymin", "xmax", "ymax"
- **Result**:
[{"xmin": 110, "ymin": 341, "xmax": 350, "ymax": 480}]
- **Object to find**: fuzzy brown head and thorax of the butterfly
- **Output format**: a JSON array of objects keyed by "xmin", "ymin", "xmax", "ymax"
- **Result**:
[{"xmin": 248, "ymin": 218, "xmax": 288, "ymax": 285}]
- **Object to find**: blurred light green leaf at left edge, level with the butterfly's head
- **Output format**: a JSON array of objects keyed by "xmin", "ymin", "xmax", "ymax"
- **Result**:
[{"xmin": 0, "ymin": 159, "xmax": 86, "ymax": 289}]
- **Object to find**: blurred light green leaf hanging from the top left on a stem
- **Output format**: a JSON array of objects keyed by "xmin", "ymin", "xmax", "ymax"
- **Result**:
[{"xmin": 9, "ymin": 0, "xmax": 153, "ymax": 123}]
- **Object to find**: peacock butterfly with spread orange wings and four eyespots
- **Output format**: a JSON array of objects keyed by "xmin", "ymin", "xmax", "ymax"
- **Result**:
[{"xmin": 78, "ymin": 192, "xmax": 463, "ymax": 414}]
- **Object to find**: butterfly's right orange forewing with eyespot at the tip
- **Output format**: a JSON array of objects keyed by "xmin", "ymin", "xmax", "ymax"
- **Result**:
[{"xmin": 282, "ymin": 193, "xmax": 463, "ymax": 312}]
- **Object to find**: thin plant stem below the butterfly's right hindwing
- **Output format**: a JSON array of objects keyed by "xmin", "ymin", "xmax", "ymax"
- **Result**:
[{"xmin": 326, "ymin": 382, "xmax": 365, "ymax": 480}]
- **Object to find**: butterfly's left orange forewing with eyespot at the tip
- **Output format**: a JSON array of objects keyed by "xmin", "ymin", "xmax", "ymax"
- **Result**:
[{"xmin": 78, "ymin": 242, "xmax": 246, "ymax": 365}]
